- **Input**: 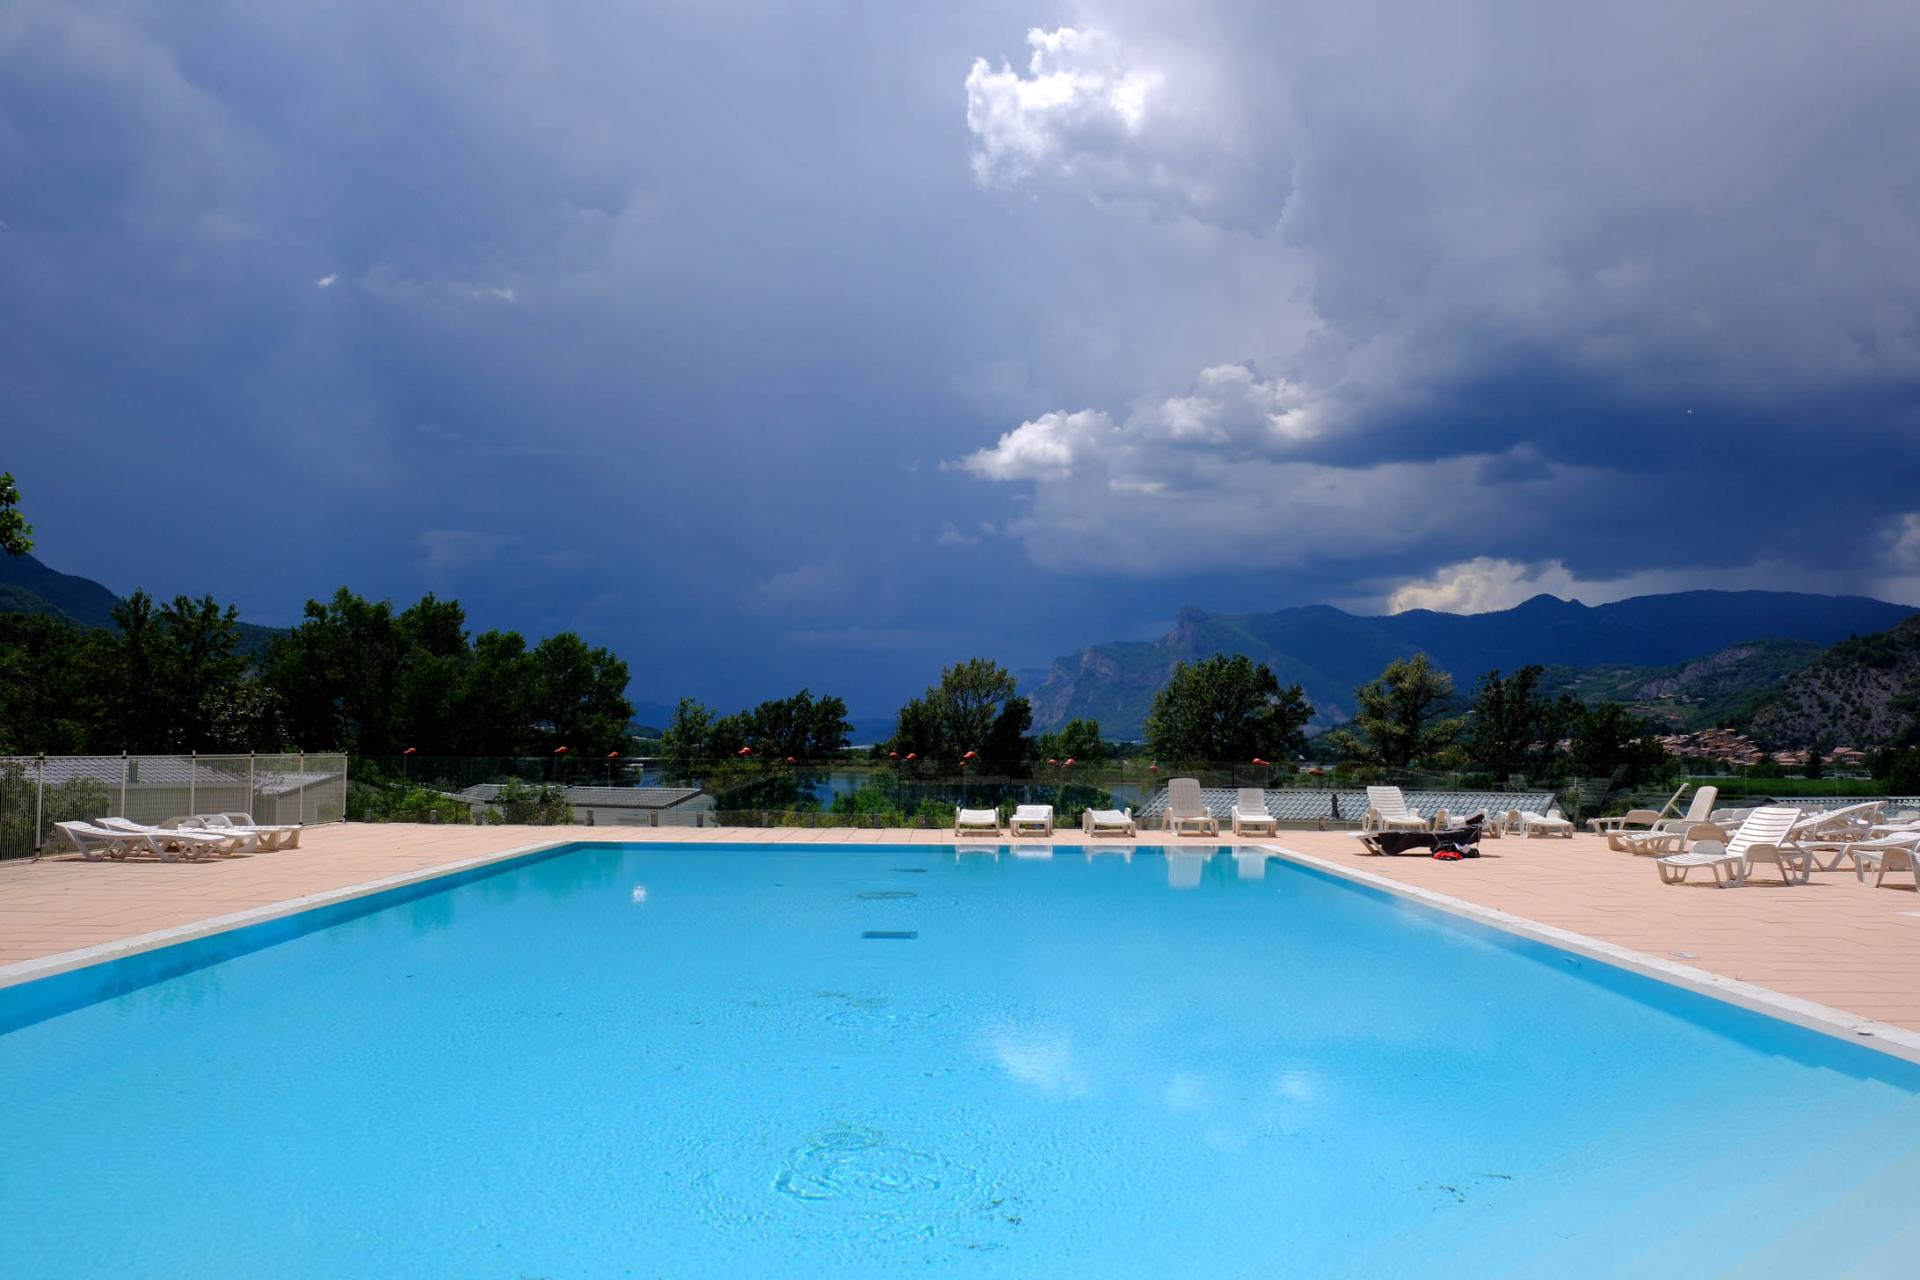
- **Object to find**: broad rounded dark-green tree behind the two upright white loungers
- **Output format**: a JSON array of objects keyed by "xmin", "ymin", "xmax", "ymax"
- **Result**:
[{"xmin": 1146, "ymin": 654, "xmax": 1313, "ymax": 764}]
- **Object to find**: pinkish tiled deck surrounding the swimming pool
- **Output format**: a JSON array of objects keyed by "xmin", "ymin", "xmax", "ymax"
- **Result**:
[{"xmin": 0, "ymin": 823, "xmax": 1920, "ymax": 1032}]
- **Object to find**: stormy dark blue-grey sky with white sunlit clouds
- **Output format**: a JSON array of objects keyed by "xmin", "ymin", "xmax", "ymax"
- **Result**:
[{"xmin": 0, "ymin": 0, "xmax": 1920, "ymax": 714}]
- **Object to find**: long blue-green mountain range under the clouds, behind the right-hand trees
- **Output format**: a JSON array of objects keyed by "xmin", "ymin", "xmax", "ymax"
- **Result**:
[{"xmin": 1029, "ymin": 591, "xmax": 1912, "ymax": 737}]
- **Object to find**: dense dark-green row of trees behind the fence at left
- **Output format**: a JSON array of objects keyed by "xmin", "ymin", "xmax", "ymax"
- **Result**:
[{"xmin": 0, "ymin": 587, "xmax": 634, "ymax": 756}]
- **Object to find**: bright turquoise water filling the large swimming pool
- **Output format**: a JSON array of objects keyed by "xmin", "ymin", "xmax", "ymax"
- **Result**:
[{"xmin": 0, "ymin": 844, "xmax": 1920, "ymax": 1278}]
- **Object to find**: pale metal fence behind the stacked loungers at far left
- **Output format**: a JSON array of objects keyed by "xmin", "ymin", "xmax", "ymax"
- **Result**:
[{"xmin": 0, "ymin": 754, "xmax": 348, "ymax": 858}]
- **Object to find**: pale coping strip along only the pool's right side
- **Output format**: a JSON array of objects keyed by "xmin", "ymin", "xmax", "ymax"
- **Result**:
[{"xmin": 1258, "ymin": 844, "xmax": 1920, "ymax": 1063}]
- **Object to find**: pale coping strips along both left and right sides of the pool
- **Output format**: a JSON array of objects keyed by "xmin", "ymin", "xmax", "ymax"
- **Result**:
[{"xmin": 0, "ymin": 839, "xmax": 1920, "ymax": 1063}]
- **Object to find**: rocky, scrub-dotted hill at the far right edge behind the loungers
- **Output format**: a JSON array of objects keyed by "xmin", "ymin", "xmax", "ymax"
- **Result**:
[{"xmin": 1751, "ymin": 616, "xmax": 1920, "ymax": 747}]
